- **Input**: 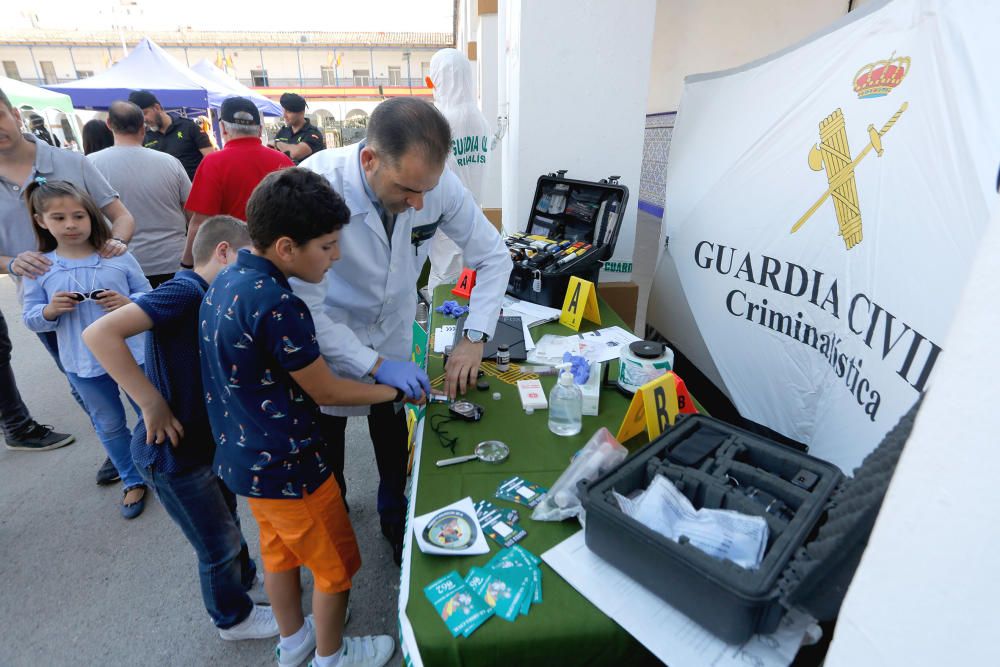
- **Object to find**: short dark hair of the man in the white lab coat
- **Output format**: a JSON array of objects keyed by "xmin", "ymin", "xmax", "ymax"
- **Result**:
[{"xmin": 368, "ymin": 97, "xmax": 451, "ymax": 165}]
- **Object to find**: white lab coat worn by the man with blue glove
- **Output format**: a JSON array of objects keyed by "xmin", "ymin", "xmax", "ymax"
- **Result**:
[{"xmin": 291, "ymin": 144, "xmax": 512, "ymax": 415}]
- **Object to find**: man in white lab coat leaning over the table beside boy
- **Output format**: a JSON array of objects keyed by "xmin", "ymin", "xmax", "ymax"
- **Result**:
[{"xmin": 293, "ymin": 97, "xmax": 512, "ymax": 563}]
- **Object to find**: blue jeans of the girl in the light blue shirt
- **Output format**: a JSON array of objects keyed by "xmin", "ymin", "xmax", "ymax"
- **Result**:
[{"xmin": 66, "ymin": 373, "xmax": 144, "ymax": 490}]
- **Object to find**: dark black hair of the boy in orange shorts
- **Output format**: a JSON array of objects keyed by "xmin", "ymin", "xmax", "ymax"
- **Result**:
[{"xmin": 247, "ymin": 167, "xmax": 351, "ymax": 250}]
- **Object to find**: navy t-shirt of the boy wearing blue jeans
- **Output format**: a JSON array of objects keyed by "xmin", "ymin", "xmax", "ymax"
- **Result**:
[{"xmin": 132, "ymin": 271, "xmax": 215, "ymax": 473}]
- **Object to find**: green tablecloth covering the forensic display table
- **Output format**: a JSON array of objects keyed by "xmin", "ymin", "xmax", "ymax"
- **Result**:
[{"xmin": 400, "ymin": 286, "xmax": 672, "ymax": 667}]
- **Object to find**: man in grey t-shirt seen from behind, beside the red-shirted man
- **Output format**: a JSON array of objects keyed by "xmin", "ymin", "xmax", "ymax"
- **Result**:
[{"xmin": 87, "ymin": 101, "xmax": 191, "ymax": 287}]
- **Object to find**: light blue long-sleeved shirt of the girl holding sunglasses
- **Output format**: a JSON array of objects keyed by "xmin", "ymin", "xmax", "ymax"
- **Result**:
[{"xmin": 23, "ymin": 251, "xmax": 152, "ymax": 378}]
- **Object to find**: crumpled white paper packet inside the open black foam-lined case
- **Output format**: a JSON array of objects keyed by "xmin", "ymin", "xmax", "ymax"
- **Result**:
[{"xmin": 614, "ymin": 475, "xmax": 767, "ymax": 570}]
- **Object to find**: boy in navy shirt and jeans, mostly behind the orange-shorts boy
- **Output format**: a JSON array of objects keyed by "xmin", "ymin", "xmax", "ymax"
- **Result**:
[{"xmin": 83, "ymin": 216, "xmax": 278, "ymax": 640}]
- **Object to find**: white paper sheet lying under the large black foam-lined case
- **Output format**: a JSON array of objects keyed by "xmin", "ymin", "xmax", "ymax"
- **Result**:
[{"xmin": 542, "ymin": 530, "xmax": 817, "ymax": 667}]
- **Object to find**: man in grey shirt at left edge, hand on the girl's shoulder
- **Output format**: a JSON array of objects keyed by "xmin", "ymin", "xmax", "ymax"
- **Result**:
[{"xmin": 0, "ymin": 90, "xmax": 135, "ymax": 460}]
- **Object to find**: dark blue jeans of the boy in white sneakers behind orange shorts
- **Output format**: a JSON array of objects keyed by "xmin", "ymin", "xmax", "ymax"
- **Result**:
[{"xmin": 142, "ymin": 462, "xmax": 257, "ymax": 629}]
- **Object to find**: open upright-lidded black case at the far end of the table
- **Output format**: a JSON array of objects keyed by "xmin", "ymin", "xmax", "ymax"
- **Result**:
[{"xmin": 507, "ymin": 170, "xmax": 628, "ymax": 308}]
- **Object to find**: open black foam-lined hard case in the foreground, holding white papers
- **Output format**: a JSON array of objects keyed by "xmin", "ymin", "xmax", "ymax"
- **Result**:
[{"xmin": 580, "ymin": 406, "xmax": 917, "ymax": 644}]
